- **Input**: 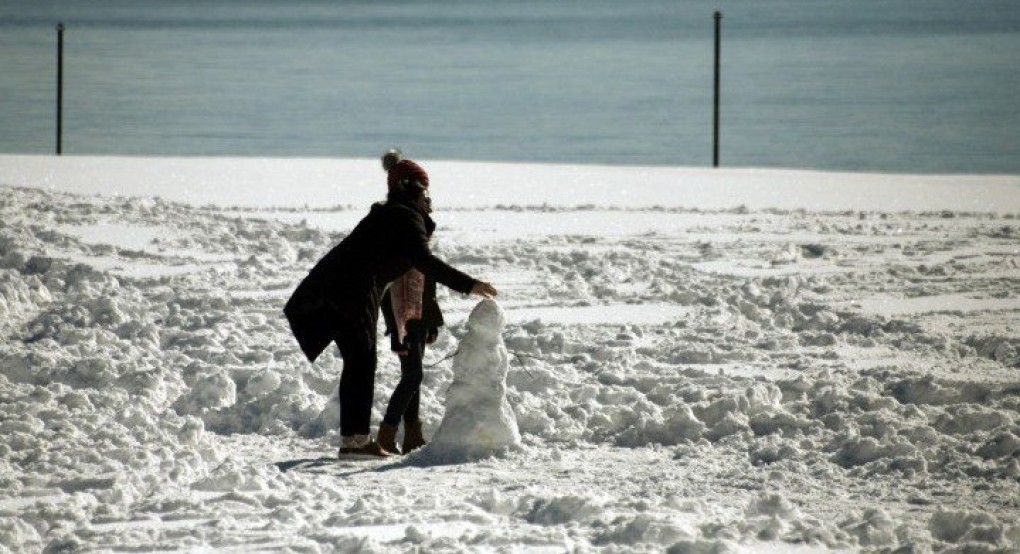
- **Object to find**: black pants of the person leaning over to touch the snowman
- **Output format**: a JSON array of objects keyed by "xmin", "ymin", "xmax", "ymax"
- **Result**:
[{"xmin": 335, "ymin": 325, "xmax": 376, "ymax": 437}]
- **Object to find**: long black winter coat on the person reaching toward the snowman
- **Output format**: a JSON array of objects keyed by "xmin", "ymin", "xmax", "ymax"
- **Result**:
[{"xmin": 284, "ymin": 202, "xmax": 476, "ymax": 361}]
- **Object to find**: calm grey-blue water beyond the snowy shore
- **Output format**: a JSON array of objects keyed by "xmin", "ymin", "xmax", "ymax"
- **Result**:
[{"xmin": 0, "ymin": 0, "xmax": 1020, "ymax": 173}]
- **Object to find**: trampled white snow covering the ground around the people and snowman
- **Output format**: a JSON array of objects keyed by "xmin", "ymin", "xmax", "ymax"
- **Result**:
[{"xmin": 0, "ymin": 156, "xmax": 1020, "ymax": 553}]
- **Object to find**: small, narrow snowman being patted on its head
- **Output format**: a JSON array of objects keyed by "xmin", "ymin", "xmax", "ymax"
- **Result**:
[{"xmin": 421, "ymin": 300, "xmax": 520, "ymax": 462}]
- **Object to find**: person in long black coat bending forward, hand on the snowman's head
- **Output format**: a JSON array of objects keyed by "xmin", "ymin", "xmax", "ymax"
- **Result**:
[{"xmin": 284, "ymin": 181, "xmax": 497, "ymax": 456}]
